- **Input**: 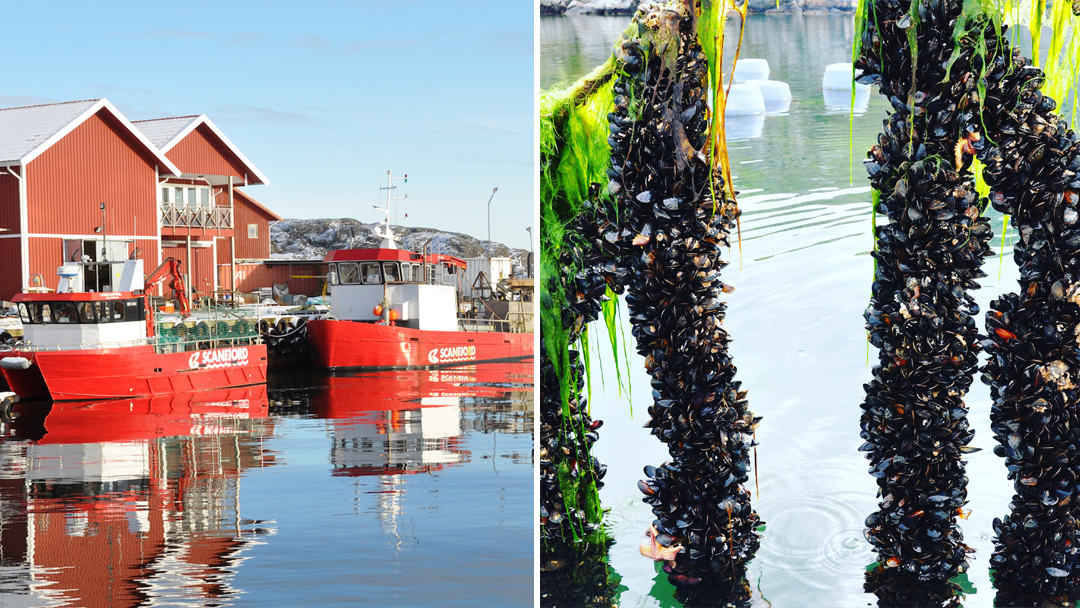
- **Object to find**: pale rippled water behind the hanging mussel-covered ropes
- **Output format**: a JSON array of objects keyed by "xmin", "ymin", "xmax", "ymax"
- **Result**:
[{"xmin": 540, "ymin": 14, "xmax": 1017, "ymax": 607}]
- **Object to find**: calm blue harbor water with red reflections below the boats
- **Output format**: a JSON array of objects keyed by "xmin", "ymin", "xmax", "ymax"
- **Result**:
[{"xmin": 0, "ymin": 362, "xmax": 534, "ymax": 608}]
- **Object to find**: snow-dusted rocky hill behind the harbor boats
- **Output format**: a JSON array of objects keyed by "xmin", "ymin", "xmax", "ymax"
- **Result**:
[{"xmin": 270, "ymin": 217, "xmax": 529, "ymax": 278}]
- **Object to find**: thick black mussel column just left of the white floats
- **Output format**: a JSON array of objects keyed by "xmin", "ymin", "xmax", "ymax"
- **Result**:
[{"xmin": 604, "ymin": 3, "xmax": 761, "ymax": 605}]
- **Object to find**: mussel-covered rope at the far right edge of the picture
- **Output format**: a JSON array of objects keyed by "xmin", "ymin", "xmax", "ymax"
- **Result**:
[{"xmin": 974, "ymin": 28, "xmax": 1080, "ymax": 606}]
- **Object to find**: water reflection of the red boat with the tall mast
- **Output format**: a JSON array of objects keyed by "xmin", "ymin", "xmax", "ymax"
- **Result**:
[{"xmin": 293, "ymin": 363, "xmax": 532, "ymax": 549}]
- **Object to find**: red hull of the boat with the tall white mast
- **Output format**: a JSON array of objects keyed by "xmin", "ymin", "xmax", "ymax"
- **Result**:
[{"xmin": 307, "ymin": 320, "xmax": 535, "ymax": 369}]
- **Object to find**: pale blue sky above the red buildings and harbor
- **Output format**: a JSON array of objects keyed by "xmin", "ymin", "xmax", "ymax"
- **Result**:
[{"xmin": 0, "ymin": 0, "xmax": 535, "ymax": 248}]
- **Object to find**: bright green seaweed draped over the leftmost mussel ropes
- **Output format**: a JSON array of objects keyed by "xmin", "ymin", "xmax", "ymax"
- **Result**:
[{"xmin": 540, "ymin": 0, "xmax": 746, "ymax": 542}]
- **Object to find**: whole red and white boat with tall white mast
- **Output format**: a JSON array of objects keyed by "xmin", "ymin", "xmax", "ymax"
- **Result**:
[{"xmin": 307, "ymin": 172, "xmax": 534, "ymax": 369}]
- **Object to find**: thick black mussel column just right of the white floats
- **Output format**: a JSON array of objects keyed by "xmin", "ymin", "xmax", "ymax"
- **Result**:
[{"xmin": 855, "ymin": 0, "xmax": 991, "ymax": 583}]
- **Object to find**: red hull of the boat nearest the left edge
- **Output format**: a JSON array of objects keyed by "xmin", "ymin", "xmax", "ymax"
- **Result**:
[{"xmin": 0, "ymin": 344, "xmax": 267, "ymax": 401}]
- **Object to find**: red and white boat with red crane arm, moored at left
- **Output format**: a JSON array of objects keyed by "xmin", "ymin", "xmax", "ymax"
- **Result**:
[{"xmin": 0, "ymin": 258, "xmax": 267, "ymax": 401}]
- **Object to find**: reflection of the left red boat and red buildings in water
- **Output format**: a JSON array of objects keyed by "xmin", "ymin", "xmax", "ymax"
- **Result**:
[{"xmin": 0, "ymin": 386, "xmax": 274, "ymax": 608}]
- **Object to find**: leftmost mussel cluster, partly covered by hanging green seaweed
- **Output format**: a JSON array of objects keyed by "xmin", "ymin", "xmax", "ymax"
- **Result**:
[{"xmin": 540, "ymin": 151, "xmax": 627, "ymax": 607}]
